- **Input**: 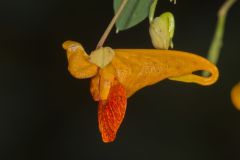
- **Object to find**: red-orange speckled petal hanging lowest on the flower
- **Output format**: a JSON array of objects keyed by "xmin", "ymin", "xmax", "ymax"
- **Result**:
[{"xmin": 98, "ymin": 80, "xmax": 127, "ymax": 143}]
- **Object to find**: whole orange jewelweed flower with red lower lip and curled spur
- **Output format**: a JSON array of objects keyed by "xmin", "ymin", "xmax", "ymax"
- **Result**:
[{"xmin": 63, "ymin": 41, "xmax": 218, "ymax": 142}]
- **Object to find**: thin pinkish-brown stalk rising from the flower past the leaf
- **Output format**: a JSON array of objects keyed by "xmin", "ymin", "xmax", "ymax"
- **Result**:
[{"xmin": 96, "ymin": 0, "xmax": 128, "ymax": 49}]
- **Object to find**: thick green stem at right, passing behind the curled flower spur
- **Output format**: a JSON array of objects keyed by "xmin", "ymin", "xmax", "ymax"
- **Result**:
[{"xmin": 203, "ymin": 0, "xmax": 237, "ymax": 76}]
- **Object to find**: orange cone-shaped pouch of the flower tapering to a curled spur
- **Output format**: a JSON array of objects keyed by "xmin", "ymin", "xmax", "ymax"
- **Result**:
[{"xmin": 111, "ymin": 49, "xmax": 218, "ymax": 97}]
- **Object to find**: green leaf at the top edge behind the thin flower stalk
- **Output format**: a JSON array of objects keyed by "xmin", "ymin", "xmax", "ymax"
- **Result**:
[{"xmin": 113, "ymin": 0, "xmax": 153, "ymax": 32}]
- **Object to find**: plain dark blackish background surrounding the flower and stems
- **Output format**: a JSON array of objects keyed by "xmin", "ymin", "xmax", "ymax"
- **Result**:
[{"xmin": 0, "ymin": 0, "xmax": 240, "ymax": 160}]
